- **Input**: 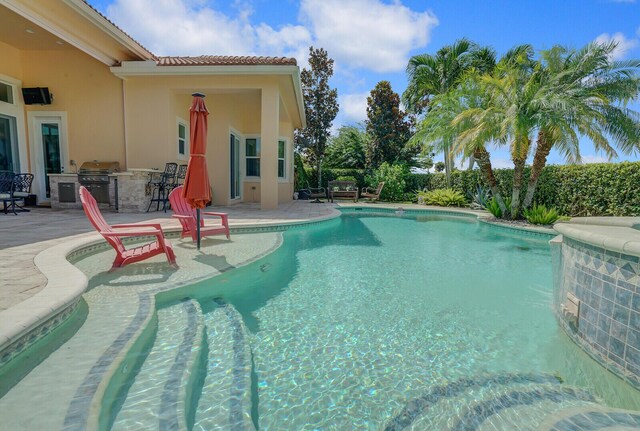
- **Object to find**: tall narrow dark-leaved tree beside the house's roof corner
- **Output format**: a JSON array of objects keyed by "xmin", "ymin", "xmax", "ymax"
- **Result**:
[{"xmin": 295, "ymin": 47, "xmax": 338, "ymax": 185}]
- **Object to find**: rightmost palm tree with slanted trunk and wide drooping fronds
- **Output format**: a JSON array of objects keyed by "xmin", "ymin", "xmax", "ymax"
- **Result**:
[{"xmin": 523, "ymin": 42, "xmax": 640, "ymax": 208}]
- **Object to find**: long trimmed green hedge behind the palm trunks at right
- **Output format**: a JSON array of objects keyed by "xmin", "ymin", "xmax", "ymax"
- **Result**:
[{"xmin": 418, "ymin": 162, "xmax": 640, "ymax": 217}]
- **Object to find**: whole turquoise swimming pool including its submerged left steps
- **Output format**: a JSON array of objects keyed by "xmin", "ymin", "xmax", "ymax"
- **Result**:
[{"xmin": 0, "ymin": 213, "xmax": 640, "ymax": 430}]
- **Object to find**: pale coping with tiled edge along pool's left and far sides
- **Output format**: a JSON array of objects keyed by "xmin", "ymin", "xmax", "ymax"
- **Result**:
[{"xmin": 0, "ymin": 203, "xmax": 555, "ymax": 366}]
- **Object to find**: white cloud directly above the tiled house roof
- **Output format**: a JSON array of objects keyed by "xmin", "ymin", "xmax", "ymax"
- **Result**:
[{"xmin": 107, "ymin": 0, "xmax": 312, "ymax": 60}]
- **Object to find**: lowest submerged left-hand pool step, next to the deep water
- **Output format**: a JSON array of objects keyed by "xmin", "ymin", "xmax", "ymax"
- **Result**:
[{"xmin": 193, "ymin": 299, "xmax": 255, "ymax": 431}]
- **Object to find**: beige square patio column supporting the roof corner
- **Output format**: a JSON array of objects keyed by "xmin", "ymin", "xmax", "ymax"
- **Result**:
[{"xmin": 260, "ymin": 83, "xmax": 280, "ymax": 210}]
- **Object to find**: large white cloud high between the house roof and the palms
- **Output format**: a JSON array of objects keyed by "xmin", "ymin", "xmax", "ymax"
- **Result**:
[{"xmin": 300, "ymin": 0, "xmax": 438, "ymax": 72}]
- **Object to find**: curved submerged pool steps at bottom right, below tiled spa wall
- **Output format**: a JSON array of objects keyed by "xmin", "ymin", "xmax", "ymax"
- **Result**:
[{"xmin": 383, "ymin": 373, "xmax": 640, "ymax": 431}]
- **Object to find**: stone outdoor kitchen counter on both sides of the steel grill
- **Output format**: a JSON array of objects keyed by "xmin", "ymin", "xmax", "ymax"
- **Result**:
[{"xmin": 49, "ymin": 168, "xmax": 158, "ymax": 213}]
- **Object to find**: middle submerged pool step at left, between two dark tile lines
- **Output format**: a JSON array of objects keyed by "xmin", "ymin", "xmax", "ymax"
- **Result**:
[{"xmin": 112, "ymin": 300, "xmax": 204, "ymax": 430}]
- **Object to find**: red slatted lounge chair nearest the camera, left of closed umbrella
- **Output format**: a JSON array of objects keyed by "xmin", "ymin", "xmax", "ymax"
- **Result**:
[{"xmin": 80, "ymin": 186, "xmax": 176, "ymax": 269}]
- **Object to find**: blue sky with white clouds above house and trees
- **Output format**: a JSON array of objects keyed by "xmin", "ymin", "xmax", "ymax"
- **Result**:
[{"xmin": 89, "ymin": 0, "xmax": 640, "ymax": 167}]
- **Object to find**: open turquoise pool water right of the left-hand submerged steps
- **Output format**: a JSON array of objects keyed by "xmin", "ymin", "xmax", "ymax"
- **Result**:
[{"xmin": 179, "ymin": 213, "xmax": 640, "ymax": 430}]
